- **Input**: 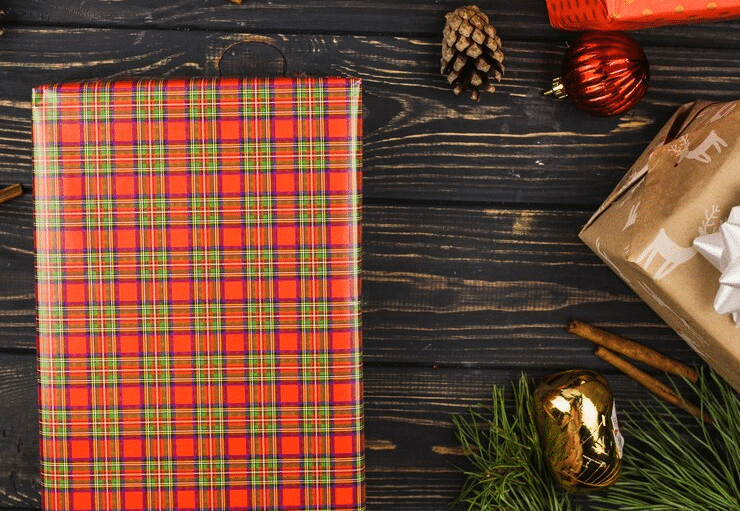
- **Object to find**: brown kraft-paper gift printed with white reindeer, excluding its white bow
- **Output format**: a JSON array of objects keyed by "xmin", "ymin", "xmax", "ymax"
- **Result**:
[{"xmin": 580, "ymin": 101, "xmax": 740, "ymax": 391}]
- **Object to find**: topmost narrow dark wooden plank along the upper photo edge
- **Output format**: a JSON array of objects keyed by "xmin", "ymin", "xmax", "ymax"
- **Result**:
[{"xmin": 3, "ymin": 0, "xmax": 740, "ymax": 48}]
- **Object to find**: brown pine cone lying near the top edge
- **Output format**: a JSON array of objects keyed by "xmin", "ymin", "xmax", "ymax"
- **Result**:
[{"xmin": 441, "ymin": 5, "xmax": 504, "ymax": 101}]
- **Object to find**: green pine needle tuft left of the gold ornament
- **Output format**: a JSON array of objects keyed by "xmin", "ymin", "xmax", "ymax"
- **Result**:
[{"xmin": 451, "ymin": 375, "xmax": 579, "ymax": 511}]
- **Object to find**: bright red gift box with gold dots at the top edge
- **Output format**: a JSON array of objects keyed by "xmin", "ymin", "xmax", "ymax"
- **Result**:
[{"xmin": 547, "ymin": 0, "xmax": 740, "ymax": 30}]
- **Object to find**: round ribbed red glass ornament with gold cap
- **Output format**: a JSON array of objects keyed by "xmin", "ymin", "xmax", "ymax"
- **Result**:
[{"xmin": 545, "ymin": 31, "xmax": 650, "ymax": 117}]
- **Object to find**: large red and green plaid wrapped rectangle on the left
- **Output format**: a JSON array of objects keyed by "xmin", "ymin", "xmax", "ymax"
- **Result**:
[{"xmin": 33, "ymin": 78, "xmax": 364, "ymax": 511}]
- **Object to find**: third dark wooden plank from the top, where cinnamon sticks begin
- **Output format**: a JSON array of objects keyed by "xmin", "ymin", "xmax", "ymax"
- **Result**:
[{"xmin": 0, "ymin": 195, "xmax": 698, "ymax": 376}]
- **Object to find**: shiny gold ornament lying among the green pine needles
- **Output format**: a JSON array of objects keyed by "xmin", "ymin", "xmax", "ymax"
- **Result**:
[{"xmin": 534, "ymin": 369, "xmax": 623, "ymax": 492}]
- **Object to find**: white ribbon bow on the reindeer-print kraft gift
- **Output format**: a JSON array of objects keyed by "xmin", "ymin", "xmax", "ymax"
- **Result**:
[{"xmin": 694, "ymin": 206, "xmax": 740, "ymax": 326}]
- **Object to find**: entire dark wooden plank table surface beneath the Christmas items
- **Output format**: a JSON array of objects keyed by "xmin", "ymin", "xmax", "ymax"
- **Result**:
[{"xmin": 0, "ymin": 0, "xmax": 740, "ymax": 511}]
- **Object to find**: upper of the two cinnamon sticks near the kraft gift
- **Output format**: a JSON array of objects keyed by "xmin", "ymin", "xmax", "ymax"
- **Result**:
[{"xmin": 566, "ymin": 319, "xmax": 699, "ymax": 383}]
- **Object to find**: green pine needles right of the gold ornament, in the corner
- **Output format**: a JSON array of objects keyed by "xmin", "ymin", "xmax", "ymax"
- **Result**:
[{"xmin": 589, "ymin": 372, "xmax": 740, "ymax": 511}]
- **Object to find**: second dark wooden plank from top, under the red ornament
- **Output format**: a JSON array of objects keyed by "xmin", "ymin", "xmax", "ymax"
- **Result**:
[{"xmin": 0, "ymin": 28, "xmax": 740, "ymax": 204}]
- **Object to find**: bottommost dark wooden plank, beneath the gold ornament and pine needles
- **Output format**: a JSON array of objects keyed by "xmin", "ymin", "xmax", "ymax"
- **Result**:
[{"xmin": 0, "ymin": 354, "xmax": 712, "ymax": 511}]
